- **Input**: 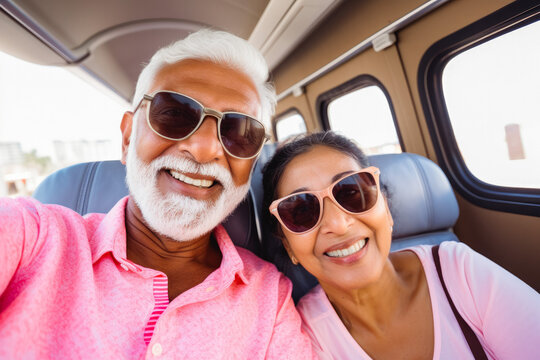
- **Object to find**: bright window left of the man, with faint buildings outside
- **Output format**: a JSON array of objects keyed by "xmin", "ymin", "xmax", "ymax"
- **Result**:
[{"xmin": 0, "ymin": 52, "xmax": 129, "ymax": 196}]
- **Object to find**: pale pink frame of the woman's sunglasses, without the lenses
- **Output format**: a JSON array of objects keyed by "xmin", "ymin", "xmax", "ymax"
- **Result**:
[{"xmin": 268, "ymin": 166, "xmax": 381, "ymax": 235}]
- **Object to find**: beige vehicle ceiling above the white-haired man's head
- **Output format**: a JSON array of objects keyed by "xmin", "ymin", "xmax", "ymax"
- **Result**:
[{"xmin": 0, "ymin": 0, "xmax": 341, "ymax": 101}]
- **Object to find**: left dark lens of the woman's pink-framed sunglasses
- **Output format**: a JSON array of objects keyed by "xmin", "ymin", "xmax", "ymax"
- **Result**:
[{"xmin": 278, "ymin": 194, "xmax": 321, "ymax": 232}]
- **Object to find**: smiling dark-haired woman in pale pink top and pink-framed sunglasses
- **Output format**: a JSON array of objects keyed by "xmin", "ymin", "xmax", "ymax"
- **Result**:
[{"xmin": 264, "ymin": 132, "xmax": 540, "ymax": 359}]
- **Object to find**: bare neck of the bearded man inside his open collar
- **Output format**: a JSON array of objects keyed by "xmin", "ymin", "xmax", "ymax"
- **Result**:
[{"xmin": 126, "ymin": 198, "xmax": 222, "ymax": 300}]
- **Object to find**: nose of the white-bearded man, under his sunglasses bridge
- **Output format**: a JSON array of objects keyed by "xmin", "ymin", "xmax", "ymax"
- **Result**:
[{"xmin": 173, "ymin": 116, "xmax": 225, "ymax": 163}]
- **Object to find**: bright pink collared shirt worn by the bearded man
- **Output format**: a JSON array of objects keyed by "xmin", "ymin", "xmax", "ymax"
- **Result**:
[{"xmin": 0, "ymin": 197, "xmax": 312, "ymax": 359}]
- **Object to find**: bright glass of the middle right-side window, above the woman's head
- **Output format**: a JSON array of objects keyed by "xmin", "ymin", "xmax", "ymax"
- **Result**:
[{"xmin": 328, "ymin": 85, "xmax": 401, "ymax": 154}]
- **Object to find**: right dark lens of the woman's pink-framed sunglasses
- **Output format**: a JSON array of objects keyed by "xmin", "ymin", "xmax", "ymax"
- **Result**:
[{"xmin": 332, "ymin": 172, "xmax": 377, "ymax": 213}]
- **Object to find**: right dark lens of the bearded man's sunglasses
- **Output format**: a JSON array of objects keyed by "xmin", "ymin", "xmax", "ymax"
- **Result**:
[{"xmin": 220, "ymin": 113, "xmax": 265, "ymax": 158}]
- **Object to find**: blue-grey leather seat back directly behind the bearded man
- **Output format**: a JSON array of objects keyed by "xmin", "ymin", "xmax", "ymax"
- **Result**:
[{"xmin": 33, "ymin": 160, "xmax": 261, "ymax": 255}]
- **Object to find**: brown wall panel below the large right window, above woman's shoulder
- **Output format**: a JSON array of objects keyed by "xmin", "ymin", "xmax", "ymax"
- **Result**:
[{"xmin": 454, "ymin": 195, "xmax": 540, "ymax": 291}]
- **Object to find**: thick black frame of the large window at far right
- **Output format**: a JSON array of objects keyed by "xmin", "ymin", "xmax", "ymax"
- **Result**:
[{"xmin": 418, "ymin": 0, "xmax": 540, "ymax": 217}]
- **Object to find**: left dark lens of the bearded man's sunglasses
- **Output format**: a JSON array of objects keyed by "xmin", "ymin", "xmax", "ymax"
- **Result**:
[{"xmin": 149, "ymin": 92, "xmax": 202, "ymax": 139}]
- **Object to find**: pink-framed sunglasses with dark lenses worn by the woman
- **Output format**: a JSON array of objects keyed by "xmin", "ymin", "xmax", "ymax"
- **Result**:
[{"xmin": 270, "ymin": 166, "xmax": 380, "ymax": 234}]
